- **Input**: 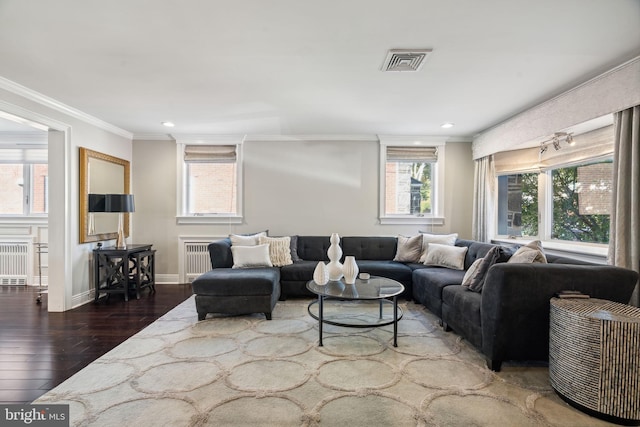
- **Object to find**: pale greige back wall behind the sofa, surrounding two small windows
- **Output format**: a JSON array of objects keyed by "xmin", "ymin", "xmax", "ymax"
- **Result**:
[{"xmin": 132, "ymin": 140, "xmax": 473, "ymax": 276}]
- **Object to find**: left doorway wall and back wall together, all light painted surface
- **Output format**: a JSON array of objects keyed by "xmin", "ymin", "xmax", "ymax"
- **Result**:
[{"xmin": 0, "ymin": 81, "xmax": 473, "ymax": 300}]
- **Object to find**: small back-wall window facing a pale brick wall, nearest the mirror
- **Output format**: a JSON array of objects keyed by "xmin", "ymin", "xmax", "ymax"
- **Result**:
[{"xmin": 178, "ymin": 142, "xmax": 242, "ymax": 223}]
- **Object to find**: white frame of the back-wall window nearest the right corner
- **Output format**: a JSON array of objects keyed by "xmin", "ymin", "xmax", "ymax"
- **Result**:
[{"xmin": 378, "ymin": 135, "xmax": 446, "ymax": 225}]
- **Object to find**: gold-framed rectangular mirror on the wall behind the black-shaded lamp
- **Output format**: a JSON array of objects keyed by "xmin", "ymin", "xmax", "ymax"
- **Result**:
[{"xmin": 80, "ymin": 147, "xmax": 131, "ymax": 243}]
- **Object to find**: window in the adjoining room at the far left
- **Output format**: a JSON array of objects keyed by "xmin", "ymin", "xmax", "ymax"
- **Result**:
[{"xmin": 0, "ymin": 148, "xmax": 49, "ymax": 216}]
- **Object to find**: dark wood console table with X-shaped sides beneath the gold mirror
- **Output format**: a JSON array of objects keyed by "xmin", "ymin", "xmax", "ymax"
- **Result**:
[{"xmin": 93, "ymin": 245, "xmax": 156, "ymax": 301}]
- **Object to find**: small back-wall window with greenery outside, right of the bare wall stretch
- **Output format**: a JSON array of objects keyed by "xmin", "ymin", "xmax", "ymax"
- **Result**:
[{"xmin": 380, "ymin": 138, "xmax": 444, "ymax": 224}]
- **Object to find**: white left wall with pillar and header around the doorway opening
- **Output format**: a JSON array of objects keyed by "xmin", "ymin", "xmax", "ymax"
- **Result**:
[{"xmin": 0, "ymin": 88, "xmax": 132, "ymax": 311}]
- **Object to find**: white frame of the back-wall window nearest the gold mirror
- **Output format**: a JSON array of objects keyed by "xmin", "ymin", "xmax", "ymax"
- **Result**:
[{"xmin": 176, "ymin": 135, "xmax": 244, "ymax": 224}]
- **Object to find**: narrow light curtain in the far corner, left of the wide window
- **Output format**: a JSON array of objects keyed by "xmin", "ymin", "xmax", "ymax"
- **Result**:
[{"xmin": 471, "ymin": 156, "xmax": 496, "ymax": 242}]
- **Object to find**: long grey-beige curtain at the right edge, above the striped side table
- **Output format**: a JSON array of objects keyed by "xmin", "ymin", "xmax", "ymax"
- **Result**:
[{"xmin": 609, "ymin": 105, "xmax": 640, "ymax": 307}]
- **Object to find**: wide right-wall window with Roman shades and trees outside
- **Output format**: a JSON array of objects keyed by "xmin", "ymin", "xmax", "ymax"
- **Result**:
[{"xmin": 493, "ymin": 126, "xmax": 614, "ymax": 247}]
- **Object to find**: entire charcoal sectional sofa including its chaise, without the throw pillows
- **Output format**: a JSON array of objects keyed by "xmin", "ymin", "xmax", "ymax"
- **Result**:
[{"xmin": 193, "ymin": 236, "xmax": 638, "ymax": 371}]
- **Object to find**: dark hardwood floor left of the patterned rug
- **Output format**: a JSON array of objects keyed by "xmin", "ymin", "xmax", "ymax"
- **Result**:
[{"xmin": 0, "ymin": 284, "xmax": 192, "ymax": 404}]
